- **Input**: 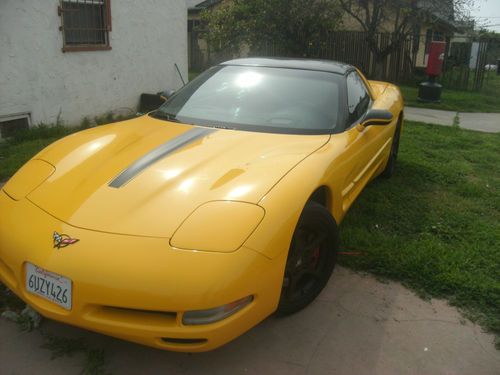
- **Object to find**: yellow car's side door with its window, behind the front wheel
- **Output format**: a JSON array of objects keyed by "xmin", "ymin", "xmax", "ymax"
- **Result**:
[{"xmin": 342, "ymin": 71, "xmax": 390, "ymax": 211}]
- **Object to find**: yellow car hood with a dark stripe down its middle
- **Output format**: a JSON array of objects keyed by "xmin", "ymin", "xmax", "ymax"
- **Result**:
[{"xmin": 28, "ymin": 116, "xmax": 329, "ymax": 237}]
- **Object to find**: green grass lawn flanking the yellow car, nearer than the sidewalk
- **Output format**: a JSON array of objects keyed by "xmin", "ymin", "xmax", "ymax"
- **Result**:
[{"xmin": 0, "ymin": 121, "xmax": 500, "ymax": 348}]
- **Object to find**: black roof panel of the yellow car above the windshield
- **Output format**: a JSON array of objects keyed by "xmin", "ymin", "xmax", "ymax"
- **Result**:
[{"xmin": 220, "ymin": 58, "xmax": 354, "ymax": 74}]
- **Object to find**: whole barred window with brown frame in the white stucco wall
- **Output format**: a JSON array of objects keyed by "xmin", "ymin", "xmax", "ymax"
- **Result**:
[{"xmin": 58, "ymin": 0, "xmax": 111, "ymax": 52}]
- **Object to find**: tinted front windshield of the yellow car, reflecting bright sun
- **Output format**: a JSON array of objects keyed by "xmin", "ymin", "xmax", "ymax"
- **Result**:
[{"xmin": 152, "ymin": 66, "xmax": 342, "ymax": 134}]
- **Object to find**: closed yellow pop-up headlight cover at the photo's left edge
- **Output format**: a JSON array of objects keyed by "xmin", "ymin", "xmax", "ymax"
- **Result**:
[{"xmin": 3, "ymin": 159, "xmax": 56, "ymax": 201}]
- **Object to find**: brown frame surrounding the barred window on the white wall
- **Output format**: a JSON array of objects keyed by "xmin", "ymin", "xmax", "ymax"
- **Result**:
[{"xmin": 57, "ymin": 0, "xmax": 112, "ymax": 52}]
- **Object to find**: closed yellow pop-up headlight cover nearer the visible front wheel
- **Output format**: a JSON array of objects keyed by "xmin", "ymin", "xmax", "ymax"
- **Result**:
[{"xmin": 170, "ymin": 201, "xmax": 264, "ymax": 253}]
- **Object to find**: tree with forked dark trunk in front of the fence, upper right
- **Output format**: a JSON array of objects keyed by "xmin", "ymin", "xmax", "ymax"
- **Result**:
[{"xmin": 339, "ymin": 0, "xmax": 474, "ymax": 78}]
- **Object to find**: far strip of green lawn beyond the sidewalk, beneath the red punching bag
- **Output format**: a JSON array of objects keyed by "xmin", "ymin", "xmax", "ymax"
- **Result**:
[{"xmin": 400, "ymin": 72, "xmax": 500, "ymax": 112}]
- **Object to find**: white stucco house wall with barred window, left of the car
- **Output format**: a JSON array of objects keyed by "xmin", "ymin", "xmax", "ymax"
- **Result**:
[{"xmin": 0, "ymin": 0, "xmax": 187, "ymax": 135}]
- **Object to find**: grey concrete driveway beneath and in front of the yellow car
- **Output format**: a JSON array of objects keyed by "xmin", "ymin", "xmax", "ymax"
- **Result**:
[{"xmin": 0, "ymin": 268, "xmax": 500, "ymax": 375}]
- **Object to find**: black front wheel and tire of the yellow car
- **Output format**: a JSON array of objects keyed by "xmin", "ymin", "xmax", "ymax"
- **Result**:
[{"xmin": 276, "ymin": 201, "xmax": 339, "ymax": 316}]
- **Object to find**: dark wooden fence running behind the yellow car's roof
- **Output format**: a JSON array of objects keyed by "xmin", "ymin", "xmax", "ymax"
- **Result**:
[{"xmin": 188, "ymin": 31, "xmax": 488, "ymax": 91}]
